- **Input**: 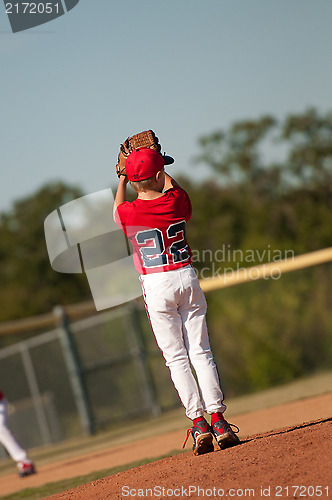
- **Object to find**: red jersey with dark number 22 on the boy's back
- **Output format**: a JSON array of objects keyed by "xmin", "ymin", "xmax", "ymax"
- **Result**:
[{"xmin": 114, "ymin": 187, "xmax": 192, "ymax": 274}]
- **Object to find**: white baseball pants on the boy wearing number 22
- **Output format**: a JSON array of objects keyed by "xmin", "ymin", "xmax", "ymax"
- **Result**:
[{"xmin": 140, "ymin": 266, "xmax": 226, "ymax": 420}]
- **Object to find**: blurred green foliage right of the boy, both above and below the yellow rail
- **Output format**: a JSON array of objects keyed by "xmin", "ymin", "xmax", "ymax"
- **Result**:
[{"xmin": 186, "ymin": 109, "xmax": 332, "ymax": 395}]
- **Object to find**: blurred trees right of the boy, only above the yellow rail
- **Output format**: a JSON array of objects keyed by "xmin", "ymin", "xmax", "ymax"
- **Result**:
[{"xmin": 186, "ymin": 109, "xmax": 332, "ymax": 260}]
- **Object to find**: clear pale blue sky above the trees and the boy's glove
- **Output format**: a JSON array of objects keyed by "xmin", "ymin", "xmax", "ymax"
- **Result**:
[{"xmin": 0, "ymin": 0, "xmax": 332, "ymax": 211}]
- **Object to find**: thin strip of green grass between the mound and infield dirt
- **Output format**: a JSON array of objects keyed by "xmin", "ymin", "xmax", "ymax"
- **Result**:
[{"xmin": 1, "ymin": 450, "xmax": 184, "ymax": 500}]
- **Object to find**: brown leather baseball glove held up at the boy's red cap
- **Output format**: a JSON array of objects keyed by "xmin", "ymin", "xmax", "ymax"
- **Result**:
[{"xmin": 115, "ymin": 130, "xmax": 174, "ymax": 177}]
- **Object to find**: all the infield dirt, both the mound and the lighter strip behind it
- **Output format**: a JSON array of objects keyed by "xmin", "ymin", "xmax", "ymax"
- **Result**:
[{"xmin": 0, "ymin": 392, "xmax": 332, "ymax": 500}]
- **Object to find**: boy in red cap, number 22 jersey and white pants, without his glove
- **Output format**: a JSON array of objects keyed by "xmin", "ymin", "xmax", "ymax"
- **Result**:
[{"xmin": 114, "ymin": 147, "xmax": 239, "ymax": 455}]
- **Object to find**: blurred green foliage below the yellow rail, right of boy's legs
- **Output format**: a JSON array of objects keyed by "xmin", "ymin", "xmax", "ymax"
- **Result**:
[{"xmin": 207, "ymin": 264, "xmax": 332, "ymax": 397}]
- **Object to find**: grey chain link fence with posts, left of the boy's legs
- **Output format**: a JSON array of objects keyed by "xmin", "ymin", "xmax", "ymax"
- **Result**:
[{"xmin": 0, "ymin": 301, "xmax": 180, "ymax": 456}]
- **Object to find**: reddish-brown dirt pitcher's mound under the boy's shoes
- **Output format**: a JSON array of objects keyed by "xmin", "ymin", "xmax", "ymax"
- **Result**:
[{"xmin": 49, "ymin": 418, "xmax": 332, "ymax": 500}]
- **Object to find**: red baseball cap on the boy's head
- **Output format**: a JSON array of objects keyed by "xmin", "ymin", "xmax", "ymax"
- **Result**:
[{"xmin": 126, "ymin": 148, "xmax": 165, "ymax": 181}]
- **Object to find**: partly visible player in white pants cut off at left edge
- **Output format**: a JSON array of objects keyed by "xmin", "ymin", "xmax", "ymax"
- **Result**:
[{"xmin": 0, "ymin": 391, "xmax": 36, "ymax": 477}]
